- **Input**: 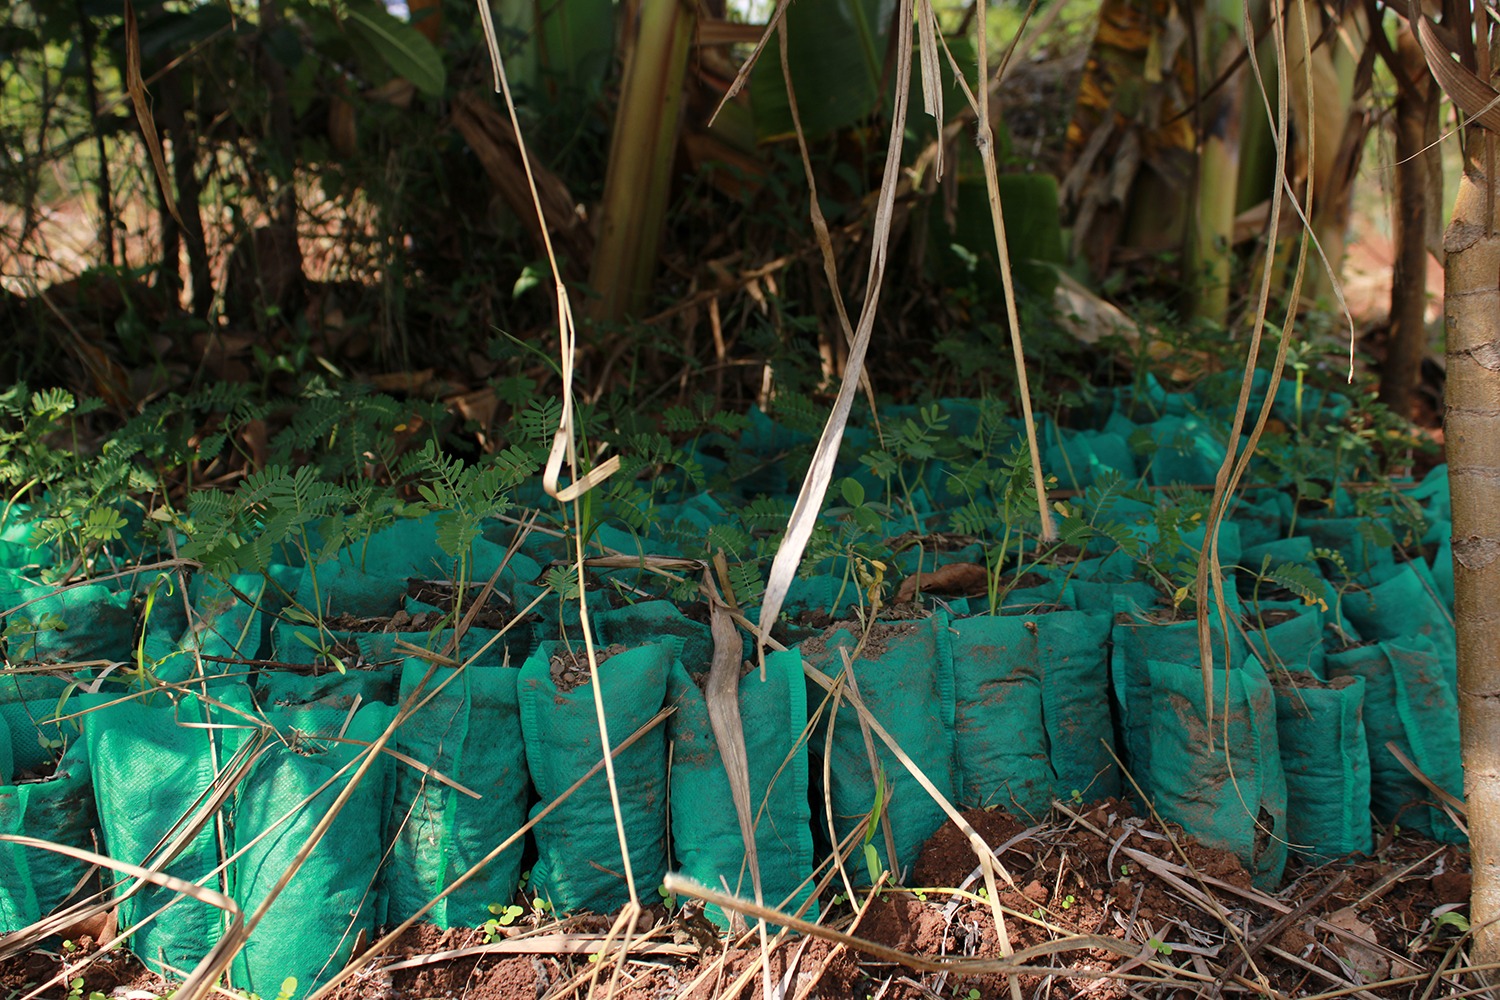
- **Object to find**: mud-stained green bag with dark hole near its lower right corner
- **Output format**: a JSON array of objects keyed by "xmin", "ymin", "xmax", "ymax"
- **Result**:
[{"xmin": 1146, "ymin": 658, "xmax": 1287, "ymax": 889}]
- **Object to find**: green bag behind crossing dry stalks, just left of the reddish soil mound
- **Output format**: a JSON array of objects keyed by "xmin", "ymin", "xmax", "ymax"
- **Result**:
[{"xmin": 800, "ymin": 612, "xmax": 959, "ymax": 885}]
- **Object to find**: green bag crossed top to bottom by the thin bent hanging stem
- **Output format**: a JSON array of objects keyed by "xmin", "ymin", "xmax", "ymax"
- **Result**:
[{"xmin": 521, "ymin": 642, "xmax": 677, "ymax": 913}]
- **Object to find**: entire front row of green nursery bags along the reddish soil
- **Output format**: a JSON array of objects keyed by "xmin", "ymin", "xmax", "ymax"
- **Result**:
[{"xmin": 0, "ymin": 494, "xmax": 1461, "ymax": 996}]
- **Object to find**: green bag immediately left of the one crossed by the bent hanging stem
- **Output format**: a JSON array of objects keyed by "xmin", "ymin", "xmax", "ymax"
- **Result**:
[{"xmin": 386, "ymin": 660, "xmax": 531, "ymax": 928}]
